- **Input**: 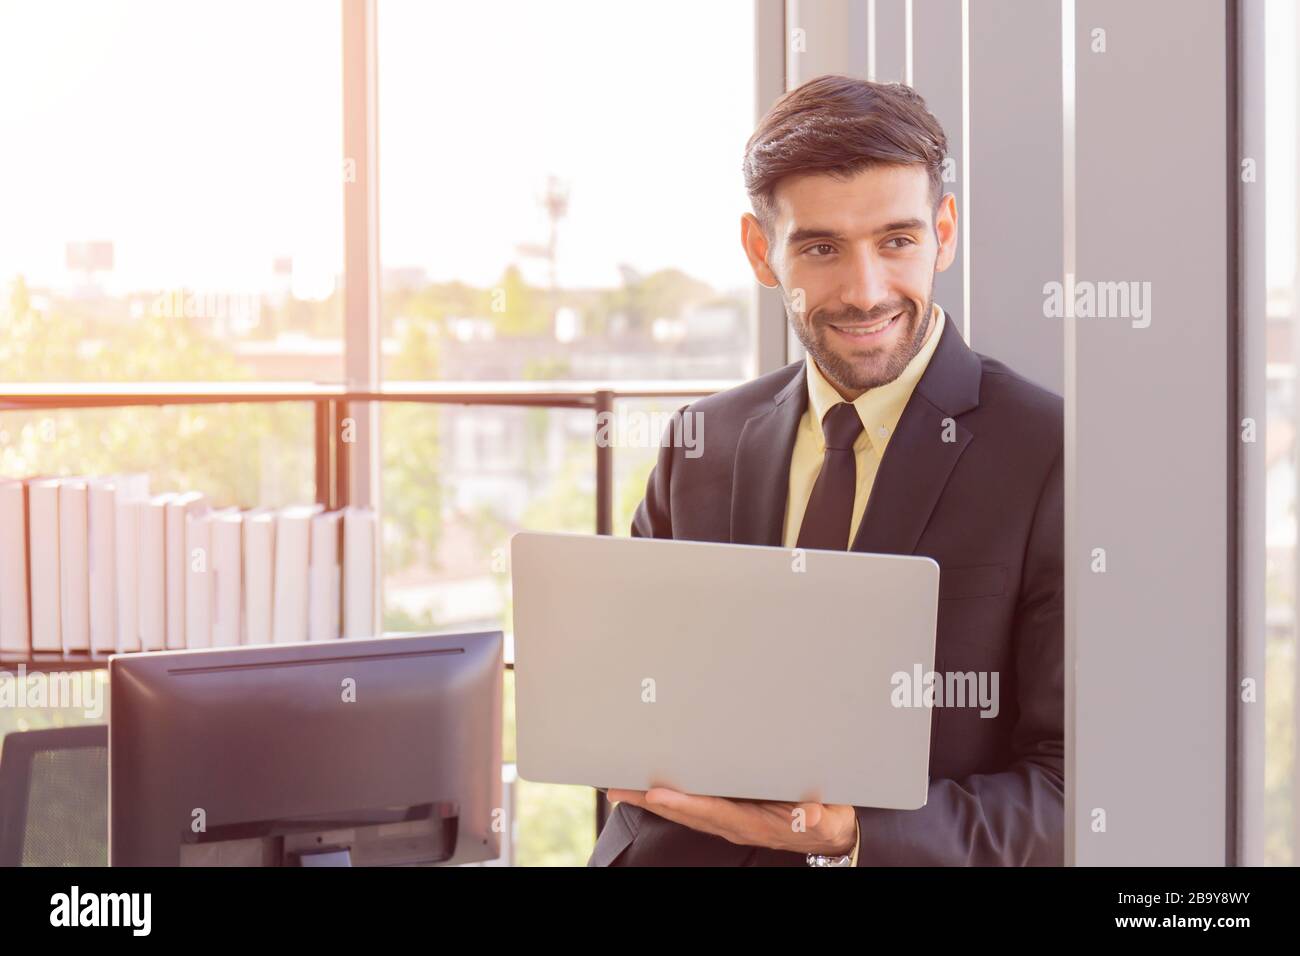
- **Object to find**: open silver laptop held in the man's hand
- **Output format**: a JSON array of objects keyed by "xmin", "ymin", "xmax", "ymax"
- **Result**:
[{"xmin": 511, "ymin": 532, "xmax": 939, "ymax": 809}]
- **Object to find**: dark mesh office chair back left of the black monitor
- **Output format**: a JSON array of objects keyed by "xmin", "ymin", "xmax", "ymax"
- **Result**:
[{"xmin": 0, "ymin": 723, "xmax": 108, "ymax": 866}]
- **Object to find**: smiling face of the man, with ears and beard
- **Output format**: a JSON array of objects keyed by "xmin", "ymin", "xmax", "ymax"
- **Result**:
[{"xmin": 742, "ymin": 165, "xmax": 957, "ymax": 401}]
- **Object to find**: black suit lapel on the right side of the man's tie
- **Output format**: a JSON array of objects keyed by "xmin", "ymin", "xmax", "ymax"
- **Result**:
[{"xmin": 850, "ymin": 312, "xmax": 980, "ymax": 554}]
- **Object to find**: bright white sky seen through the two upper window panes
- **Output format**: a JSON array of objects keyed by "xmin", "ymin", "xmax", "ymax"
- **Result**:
[{"xmin": 0, "ymin": 0, "xmax": 754, "ymax": 291}]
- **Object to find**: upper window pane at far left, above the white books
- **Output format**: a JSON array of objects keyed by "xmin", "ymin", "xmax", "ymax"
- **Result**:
[{"xmin": 0, "ymin": 0, "xmax": 347, "ymax": 381}]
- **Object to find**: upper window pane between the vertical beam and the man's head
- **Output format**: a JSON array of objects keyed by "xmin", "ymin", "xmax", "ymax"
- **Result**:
[{"xmin": 378, "ymin": 0, "xmax": 754, "ymax": 380}]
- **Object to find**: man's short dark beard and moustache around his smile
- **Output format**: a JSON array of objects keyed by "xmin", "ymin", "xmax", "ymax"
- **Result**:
[{"xmin": 785, "ymin": 289, "xmax": 935, "ymax": 393}]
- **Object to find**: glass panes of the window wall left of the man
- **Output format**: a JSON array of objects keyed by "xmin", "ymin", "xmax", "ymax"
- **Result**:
[{"xmin": 0, "ymin": 0, "xmax": 757, "ymax": 864}]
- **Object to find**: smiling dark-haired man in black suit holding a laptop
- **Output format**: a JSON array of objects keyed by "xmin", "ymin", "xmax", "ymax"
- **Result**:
[{"xmin": 589, "ymin": 75, "xmax": 1065, "ymax": 866}]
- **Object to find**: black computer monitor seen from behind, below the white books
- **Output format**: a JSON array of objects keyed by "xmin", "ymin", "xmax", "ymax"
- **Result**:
[{"xmin": 108, "ymin": 631, "xmax": 504, "ymax": 866}]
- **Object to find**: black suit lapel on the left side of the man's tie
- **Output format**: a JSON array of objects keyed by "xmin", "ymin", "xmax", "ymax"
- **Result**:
[{"xmin": 731, "ymin": 362, "xmax": 809, "ymax": 548}]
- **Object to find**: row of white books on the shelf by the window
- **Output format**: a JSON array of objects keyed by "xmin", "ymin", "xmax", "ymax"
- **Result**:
[{"xmin": 0, "ymin": 475, "xmax": 378, "ymax": 658}]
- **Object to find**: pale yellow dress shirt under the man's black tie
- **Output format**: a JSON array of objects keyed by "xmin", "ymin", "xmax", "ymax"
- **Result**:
[{"xmin": 784, "ymin": 306, "xmax": 944, "ymax": 866}]
